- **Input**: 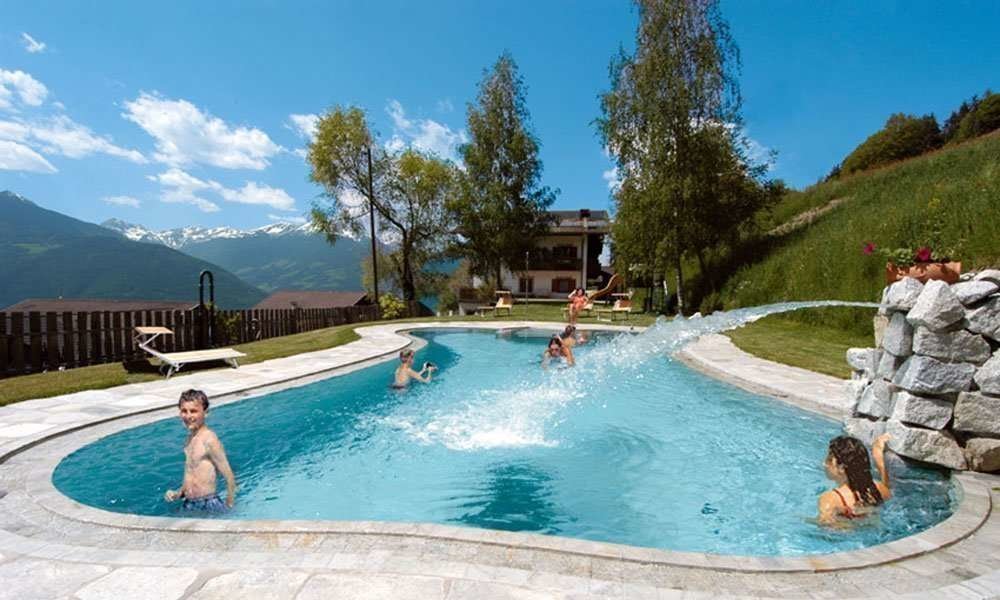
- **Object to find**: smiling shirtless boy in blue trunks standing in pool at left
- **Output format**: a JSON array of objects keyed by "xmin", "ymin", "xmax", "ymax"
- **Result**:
[{"xmin": 164, "ymin": 390, "xmax": 236, "ymax": 512}]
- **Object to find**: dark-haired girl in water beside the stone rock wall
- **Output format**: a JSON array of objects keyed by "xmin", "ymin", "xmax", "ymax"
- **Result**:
[{"xmin": 819, "ymin": 434, "xmax": 892, "ymax": 525}]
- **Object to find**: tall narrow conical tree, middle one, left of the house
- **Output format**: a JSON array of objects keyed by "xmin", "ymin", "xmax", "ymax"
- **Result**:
[{"xmin": 450, "ymin": 53, "xmax": 555, "ymax": 287}]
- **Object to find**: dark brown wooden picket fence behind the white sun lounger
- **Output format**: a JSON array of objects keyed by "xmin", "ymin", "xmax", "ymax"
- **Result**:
[{"xmin": 0, "ymin": 302, "xmax": 429, "ymax": 378}]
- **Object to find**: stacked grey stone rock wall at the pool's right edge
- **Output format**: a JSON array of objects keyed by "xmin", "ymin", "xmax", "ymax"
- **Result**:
[{"xmin": 844, "ymin": 270, "xmax": 1000, "ymax": 471}]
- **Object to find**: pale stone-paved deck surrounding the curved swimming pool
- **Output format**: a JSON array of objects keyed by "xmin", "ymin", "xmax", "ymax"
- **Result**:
[{"xmin": 0, "ymin": 322, "xmax": 1000, "ymax": 600}]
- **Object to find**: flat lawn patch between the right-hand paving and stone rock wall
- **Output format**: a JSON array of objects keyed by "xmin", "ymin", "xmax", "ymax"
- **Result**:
[{"xmin": 726, "ymin": 315, "xmax": 875, "ymax": 379}]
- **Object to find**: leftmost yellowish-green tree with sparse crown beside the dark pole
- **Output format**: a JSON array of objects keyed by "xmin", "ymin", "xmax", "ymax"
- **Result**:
[{"xmin": 307, "ymin": 107, "xmax": 455, "ymax": 300}]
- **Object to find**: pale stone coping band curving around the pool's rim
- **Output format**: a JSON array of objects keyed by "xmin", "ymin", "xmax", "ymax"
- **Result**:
[{"xmin": 0, "ymin": 321, "xmax": 992, "ymax": 573}]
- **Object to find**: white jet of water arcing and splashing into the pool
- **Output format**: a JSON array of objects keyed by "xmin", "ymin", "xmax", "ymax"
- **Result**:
[{"xmin": 398, "ymin": 300, "xmax": 879, "ymax": 451}]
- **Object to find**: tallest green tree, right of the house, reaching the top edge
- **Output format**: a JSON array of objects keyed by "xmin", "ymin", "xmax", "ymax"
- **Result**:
[{"xmin": 597, "ymin": 0, "xmax": 766, "ymax": 311}]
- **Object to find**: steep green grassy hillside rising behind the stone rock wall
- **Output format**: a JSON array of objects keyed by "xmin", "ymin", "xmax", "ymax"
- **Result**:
[{"xmin": 721, "ymin": 135, "xmax": 1000, "ymax": 334}]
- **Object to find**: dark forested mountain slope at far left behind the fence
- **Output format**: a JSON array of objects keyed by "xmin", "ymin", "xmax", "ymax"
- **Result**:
[{"xmin": 0, "ymin": 191, "xmax": 265, "ymax": 308}]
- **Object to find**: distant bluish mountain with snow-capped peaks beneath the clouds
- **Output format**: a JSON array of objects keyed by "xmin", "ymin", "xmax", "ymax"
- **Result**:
[{"xmin": 102, "ymin": 219, "xmax": 369, "ymax": 292}]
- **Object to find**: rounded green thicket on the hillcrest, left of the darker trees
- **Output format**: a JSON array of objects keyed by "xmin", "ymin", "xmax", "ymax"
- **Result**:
[{"xmin": 840, "ymin": 113, "xmax": 942, "ymax": 175}]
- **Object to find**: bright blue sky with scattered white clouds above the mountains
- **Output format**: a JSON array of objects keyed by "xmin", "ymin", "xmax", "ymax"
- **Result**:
[{"xmin": 0, "ymin": 0, "xmax": 1000, "ymax": 229}]
